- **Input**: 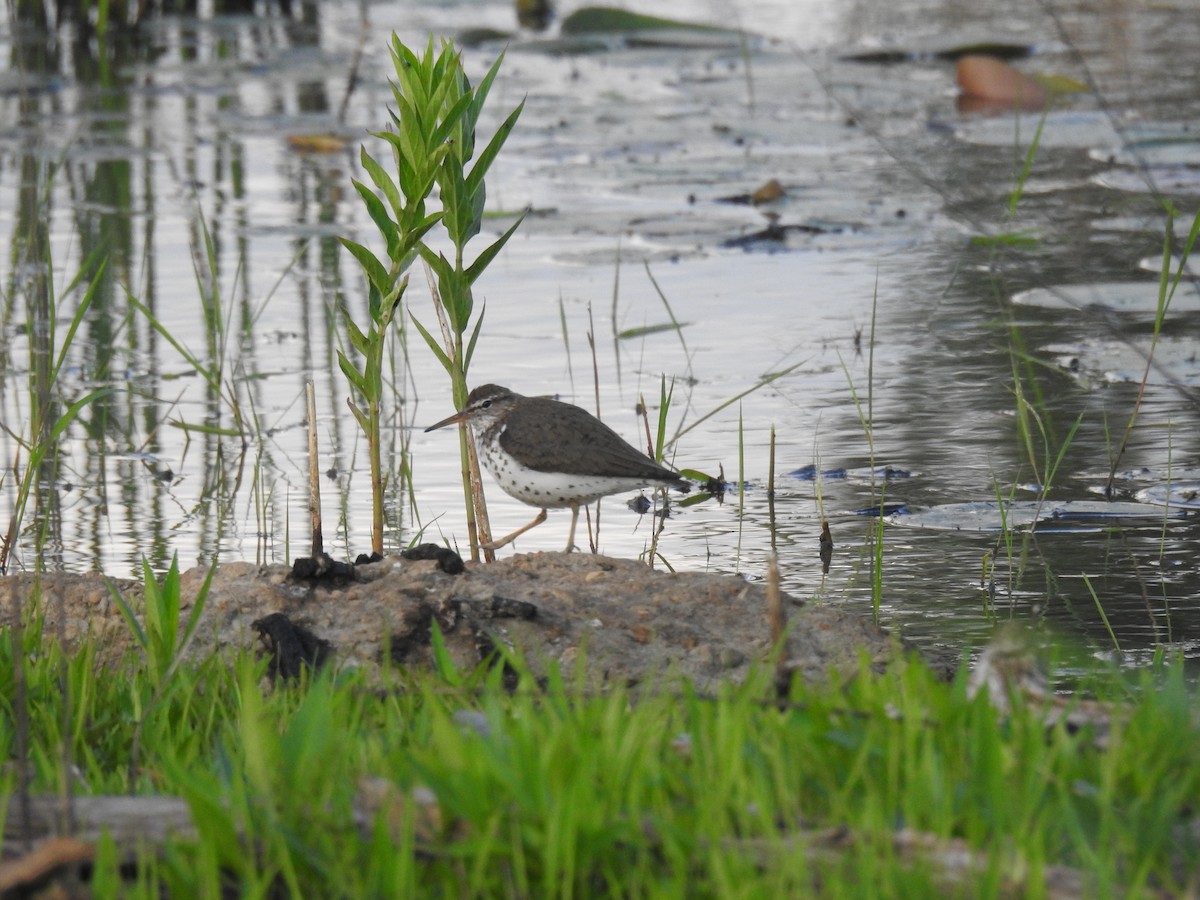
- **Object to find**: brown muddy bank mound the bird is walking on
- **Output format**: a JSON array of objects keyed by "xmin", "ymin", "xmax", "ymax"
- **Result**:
[{"xmin": 0, "ymin": 552, "xmax": 936, "ymax": 689}]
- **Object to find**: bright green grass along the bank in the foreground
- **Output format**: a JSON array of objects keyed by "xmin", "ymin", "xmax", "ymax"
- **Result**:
[{"xmin": 0, "ymin": 607, "xmax": 1200, "ymax": 898}]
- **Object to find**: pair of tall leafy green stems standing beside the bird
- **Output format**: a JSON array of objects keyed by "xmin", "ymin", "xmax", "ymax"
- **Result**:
[{"xmin": 338, "ymin": 35, "xmax": 523, "ymax": 556}]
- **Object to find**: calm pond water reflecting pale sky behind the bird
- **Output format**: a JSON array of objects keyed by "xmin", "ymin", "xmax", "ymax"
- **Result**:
[{"xmin": 0, "ymin": 1, "xmax": 1200, "ymax": 664}]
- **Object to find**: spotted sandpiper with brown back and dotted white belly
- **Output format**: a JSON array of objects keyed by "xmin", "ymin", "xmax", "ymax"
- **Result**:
[{"xmin": 425, "ymin": 384, "xmax": 688, "ymax": 552}]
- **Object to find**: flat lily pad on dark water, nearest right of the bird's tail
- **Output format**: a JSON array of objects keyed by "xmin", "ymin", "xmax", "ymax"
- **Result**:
[{"xmin": 887, "ymin": 500, "xmax": 1180, "ymax": 532}]
